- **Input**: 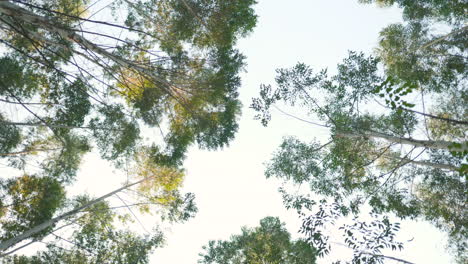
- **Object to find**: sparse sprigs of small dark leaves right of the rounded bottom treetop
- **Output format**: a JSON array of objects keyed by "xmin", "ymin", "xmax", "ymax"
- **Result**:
[{"xmin": 290, "ymin": 198, "xmax": 404, "ymax": 263}]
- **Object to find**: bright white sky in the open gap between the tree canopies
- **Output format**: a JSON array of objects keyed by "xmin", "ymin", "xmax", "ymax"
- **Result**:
[{"xmin": 72, "ymin": 0, "xmax": 450, "ymax": 264}]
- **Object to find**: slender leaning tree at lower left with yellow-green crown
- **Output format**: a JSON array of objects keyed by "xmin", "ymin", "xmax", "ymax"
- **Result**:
[{"xmin": 0, "ymin": 164, "xmax": 196, "ymax": 252}]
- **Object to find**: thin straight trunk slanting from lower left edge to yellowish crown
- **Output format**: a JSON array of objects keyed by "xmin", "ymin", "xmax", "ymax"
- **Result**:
[{"xmin": 0, "ymin": 178, "xmax": 148, "ymax": 252}]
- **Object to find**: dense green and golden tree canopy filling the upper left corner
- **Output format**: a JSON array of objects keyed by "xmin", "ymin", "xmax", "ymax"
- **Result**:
[{"xmin": 0, "ymin": 0, "xmax": 256, "ymax": 176}]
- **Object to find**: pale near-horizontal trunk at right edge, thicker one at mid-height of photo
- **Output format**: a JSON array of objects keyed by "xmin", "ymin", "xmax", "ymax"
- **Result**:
[{"xmin": 335, "ymin": 131, "xmax": 468, "ymax": 152}]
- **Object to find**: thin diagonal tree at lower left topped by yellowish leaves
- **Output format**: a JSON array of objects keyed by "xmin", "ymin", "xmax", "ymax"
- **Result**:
[{"xmin": 0, "ymin": 164, "xmax": 197, "ymax": 251}]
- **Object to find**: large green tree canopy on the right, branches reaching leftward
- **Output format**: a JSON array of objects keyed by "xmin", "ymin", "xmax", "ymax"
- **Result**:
[{"xmin": 252, "ymin": 1, "xmax": 468, "ymax": 263}]
